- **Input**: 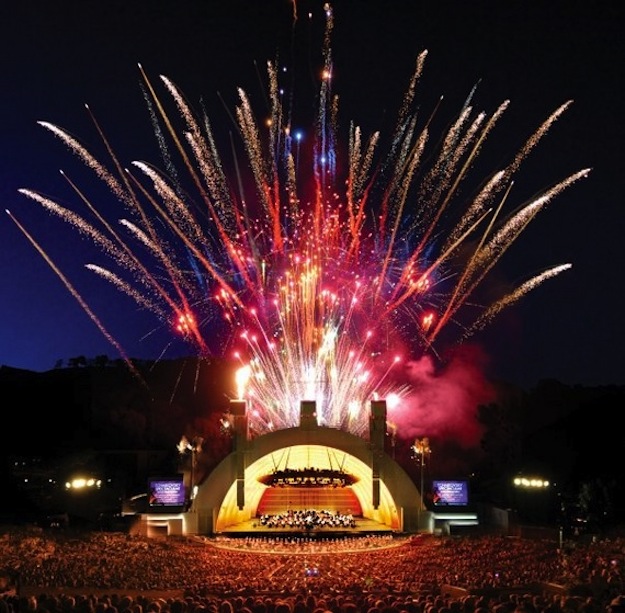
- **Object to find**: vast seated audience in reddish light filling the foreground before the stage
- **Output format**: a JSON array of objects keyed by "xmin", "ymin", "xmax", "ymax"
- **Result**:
[{"xmin": 0, "ymin": 529, "xmax": 625, "ymax": 613}]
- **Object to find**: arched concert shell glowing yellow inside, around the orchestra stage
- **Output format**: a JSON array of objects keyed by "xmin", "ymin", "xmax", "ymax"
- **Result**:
[{"xmin": 191, "ymin": 427, "xmax": 421, "ymax": 534}]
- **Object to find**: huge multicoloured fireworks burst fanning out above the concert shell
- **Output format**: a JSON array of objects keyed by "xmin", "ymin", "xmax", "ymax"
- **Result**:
[{"xmin": 10, "ymin": 7, "xmax": 589, "ymax": 433}]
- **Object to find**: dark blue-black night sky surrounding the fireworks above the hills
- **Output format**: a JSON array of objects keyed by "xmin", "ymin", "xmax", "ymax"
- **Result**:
[{"xmin": 0, "ymin": 0, "xmax": 625, "ymax": 386}]
